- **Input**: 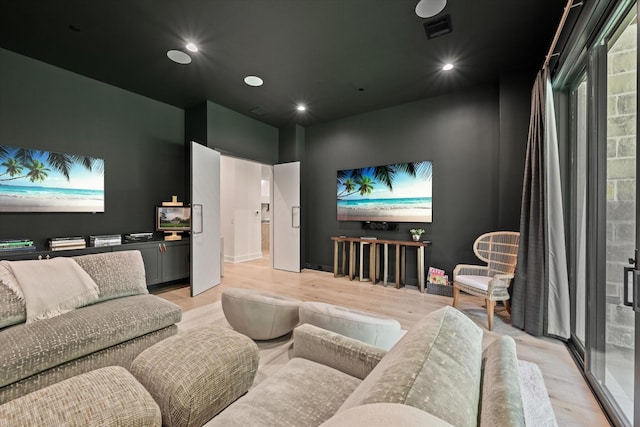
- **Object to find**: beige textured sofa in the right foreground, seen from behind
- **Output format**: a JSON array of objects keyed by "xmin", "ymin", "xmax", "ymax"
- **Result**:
[{"xmin": 207, "ymin": 307, "xmax": 544, "ymax": 426}]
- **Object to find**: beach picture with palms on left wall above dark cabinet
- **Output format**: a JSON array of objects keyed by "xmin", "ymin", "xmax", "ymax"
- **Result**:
[{"xmin": 0, "ymin": 145, "xmax": 104, "ymax": 212}]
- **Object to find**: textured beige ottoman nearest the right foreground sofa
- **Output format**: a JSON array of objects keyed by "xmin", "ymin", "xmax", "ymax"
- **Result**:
[{"xmin": 130, "ymin": 326, "xmax": 259, "ymax": 426}]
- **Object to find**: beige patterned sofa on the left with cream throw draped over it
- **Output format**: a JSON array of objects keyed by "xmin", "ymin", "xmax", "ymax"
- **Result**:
[{"xmin": 0, "ymin": 251, "xmax": 182, "ymax": 403}]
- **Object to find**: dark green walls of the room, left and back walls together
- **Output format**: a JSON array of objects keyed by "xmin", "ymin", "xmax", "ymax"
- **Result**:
[{"xmin": 0, "ymin": 45, "xmax": 532, "ymax": 280}]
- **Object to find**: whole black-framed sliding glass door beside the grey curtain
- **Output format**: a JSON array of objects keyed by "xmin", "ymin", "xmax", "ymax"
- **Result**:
[{"xmin": 569, "ymin": 1, "xmax": 640, "ymax": 425}]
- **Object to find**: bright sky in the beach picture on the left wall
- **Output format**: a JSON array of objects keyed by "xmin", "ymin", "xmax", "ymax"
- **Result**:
[{"xmin": 0, "ymin": 147, "xmax": 104, "ymax": 190}]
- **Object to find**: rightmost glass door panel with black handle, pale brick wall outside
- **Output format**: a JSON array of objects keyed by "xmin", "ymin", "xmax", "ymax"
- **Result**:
[{"xmin": 588, "ymin": 8, "xmax": 638, "ymax": 424}]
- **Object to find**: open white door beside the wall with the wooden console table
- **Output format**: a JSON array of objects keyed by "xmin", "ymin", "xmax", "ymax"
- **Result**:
[{"xmin": 271, "ymin": 162, "xmax": 301, "ymax": 273}]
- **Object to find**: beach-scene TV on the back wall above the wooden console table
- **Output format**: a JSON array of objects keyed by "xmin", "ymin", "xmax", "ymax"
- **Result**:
[{"xmin": 337, "ymin": 160, "xmax": 433, "ymax": 222}]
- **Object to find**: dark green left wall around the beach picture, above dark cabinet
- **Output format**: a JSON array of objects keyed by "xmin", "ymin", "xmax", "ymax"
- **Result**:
[{"xmin": 0, "ymin": 49, "xmax": 186, "ymax": 245}]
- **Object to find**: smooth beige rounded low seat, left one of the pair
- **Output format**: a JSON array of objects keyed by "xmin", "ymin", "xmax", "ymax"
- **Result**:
[{"xmin": 222, "ymin": 288, "xmax": 301, "ymax": 340}]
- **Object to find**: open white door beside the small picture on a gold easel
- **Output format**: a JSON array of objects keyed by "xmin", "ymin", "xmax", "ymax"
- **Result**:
[{"xmin": 190, "ymin": 142, "xmax": 221, "ymax": 296}]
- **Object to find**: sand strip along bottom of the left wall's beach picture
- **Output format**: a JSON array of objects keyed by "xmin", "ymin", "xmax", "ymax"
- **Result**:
[{"xmin": 0, "ymin": 195, "xmax": 104, "ymax": 212}]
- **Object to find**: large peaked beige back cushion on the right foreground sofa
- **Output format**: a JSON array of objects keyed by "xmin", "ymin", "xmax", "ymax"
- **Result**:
[{"xmin": 340, "ymin": 306, "xmax": 482, "ymax": 426}]
